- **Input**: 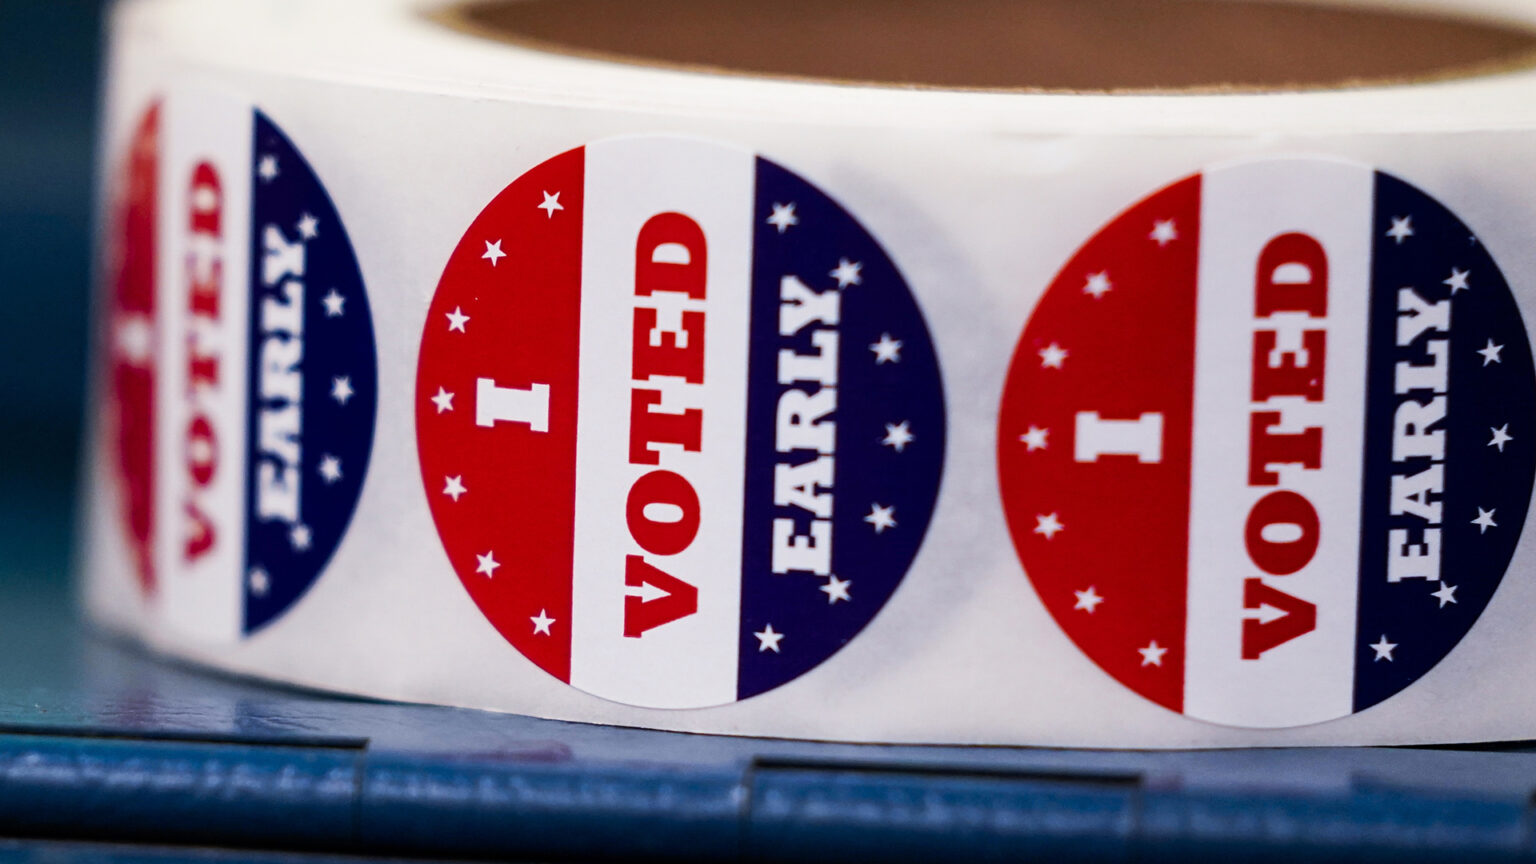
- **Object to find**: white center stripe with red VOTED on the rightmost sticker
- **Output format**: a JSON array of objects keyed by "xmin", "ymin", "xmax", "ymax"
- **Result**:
[{"xmin": 1184, "ymin": 161, "xmax": 1373, "ymax": 726}]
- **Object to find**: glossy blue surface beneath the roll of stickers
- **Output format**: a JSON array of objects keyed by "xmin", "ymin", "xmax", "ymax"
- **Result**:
[{"xmin": 9, "ymin": 479, "xmax": 1536, "ymax": 862}]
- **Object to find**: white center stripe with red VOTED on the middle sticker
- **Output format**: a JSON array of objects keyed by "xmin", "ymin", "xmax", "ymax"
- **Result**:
[{"xmin": 571, "ymin": 141, "xmax": 753, "ymax": 707}]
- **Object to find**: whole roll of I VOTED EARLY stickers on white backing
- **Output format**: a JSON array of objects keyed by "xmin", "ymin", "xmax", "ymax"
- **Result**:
[{"xmin": 81, "ymin": 0, "xmax": 1536, "ymax": 747}]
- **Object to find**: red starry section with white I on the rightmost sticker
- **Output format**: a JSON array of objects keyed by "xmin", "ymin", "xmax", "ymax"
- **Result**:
[{"xmin": 998, "ymin": 177, "xmax": 1200, "ymax": 710}]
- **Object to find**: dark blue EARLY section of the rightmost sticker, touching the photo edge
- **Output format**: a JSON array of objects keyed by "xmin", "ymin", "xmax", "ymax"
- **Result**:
[{"xmin": 1355, "ymin": 174, "xmax": 1536, "ymax": 710}]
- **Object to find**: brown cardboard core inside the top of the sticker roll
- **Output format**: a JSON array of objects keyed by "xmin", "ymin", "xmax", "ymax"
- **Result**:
[{"xmin": 445, "ymin": 0, "xmax": 1536, "ymax": 91}]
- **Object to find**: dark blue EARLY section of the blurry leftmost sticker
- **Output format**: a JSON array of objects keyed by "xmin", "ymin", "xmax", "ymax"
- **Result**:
[{"xmin": 244, "ymin": 112, "xmax": 378, "ymax": 633}]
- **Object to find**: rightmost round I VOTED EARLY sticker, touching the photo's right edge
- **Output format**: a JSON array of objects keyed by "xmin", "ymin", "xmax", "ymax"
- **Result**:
[{"xmin": 998, "ymin": 158, "xmax": 1536, "ymax": 727}]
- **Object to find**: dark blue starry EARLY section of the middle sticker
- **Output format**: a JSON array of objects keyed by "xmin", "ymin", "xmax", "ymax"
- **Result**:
[{"xmin": 737, "ymin": 158, "xmax": 945, "ymax": 698}]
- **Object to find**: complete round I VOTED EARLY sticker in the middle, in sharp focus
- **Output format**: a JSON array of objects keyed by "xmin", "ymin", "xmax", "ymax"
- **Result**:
[{"xmin": 416, "ymin": 137, "xmax": 945, "ymax": 707}]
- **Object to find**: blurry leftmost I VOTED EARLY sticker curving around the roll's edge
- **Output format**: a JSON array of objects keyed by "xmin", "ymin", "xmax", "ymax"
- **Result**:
[{"xmin": 108, "ymin": 92, "xmax": 378, "ymax": 638}]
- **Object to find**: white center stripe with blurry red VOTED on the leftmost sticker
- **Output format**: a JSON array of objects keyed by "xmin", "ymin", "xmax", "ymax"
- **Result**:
[{"xmin": 155, "ymin": 91, "xmax": 252, "ymax": 638}]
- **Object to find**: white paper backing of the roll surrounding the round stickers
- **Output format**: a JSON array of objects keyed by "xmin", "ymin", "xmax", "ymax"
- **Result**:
[{"xmin": 81, "ymin": 0, "xmax": 1536, "ymax": 747}]
